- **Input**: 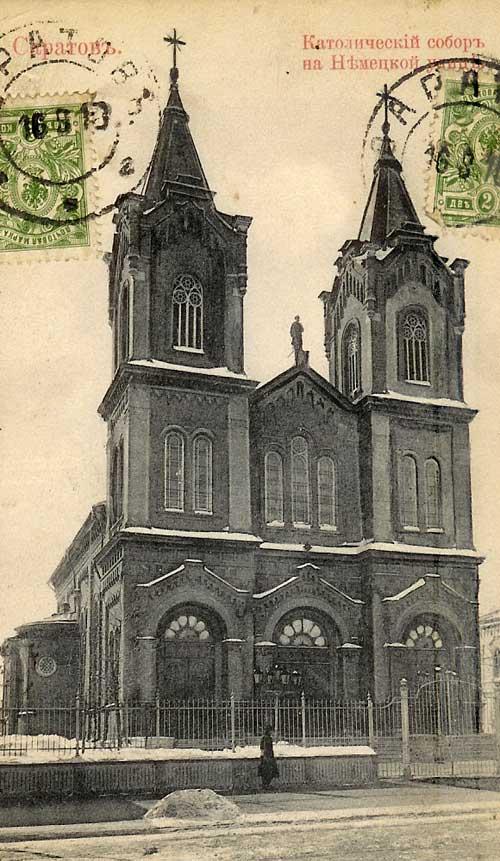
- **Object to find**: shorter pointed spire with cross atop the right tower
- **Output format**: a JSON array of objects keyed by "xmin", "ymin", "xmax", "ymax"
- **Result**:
[{"xmin": 358, "ymin": 84, "xmax": 422, "ymax": 245}]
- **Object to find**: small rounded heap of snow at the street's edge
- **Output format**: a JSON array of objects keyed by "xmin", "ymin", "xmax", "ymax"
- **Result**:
[{"xmin": 144, "ymin": 789, "xmax": 240, "ymax": 822}]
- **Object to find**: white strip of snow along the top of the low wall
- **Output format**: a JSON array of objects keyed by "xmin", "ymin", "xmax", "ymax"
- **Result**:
[{"xmin": 0, "ymin": 736, "xmax": 374, "ymax": 765}]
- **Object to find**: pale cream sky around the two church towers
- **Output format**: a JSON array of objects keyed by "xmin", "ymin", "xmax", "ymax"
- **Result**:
[{"xmin": 0, "ymin": 0, "xmax": 500, "ymax": 640}]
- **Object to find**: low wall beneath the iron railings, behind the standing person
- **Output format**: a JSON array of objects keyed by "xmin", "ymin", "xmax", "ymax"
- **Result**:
[{"xmin": 0, "ymin": 748, "xmax": 377, "ymax": 801}]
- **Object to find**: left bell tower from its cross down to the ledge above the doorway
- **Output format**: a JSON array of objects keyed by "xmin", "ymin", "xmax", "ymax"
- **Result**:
[{"xmin": 100, "ymin": 38, "xmax": 254, "ymax": 531}]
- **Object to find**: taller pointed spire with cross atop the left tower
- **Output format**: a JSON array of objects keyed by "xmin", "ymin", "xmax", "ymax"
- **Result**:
[{"xmin": 144, "ymin": 29, "xmax": 211, "ymax": 202}]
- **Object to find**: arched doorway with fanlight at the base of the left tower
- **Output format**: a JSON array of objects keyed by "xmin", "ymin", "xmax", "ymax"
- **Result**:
[{"xmin": 156, "ymin": 604, "xmax": 226, "ymax": 700}]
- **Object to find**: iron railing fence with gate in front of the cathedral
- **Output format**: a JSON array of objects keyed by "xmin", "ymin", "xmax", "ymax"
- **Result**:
[{"xmin": 0, "ymin": 678, "xmax": 496, "ymax": 768}]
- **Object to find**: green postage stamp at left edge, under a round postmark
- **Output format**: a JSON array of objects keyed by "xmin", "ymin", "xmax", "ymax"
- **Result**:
[{"xmin": 0, "ymin": 96, "xmax": 91, "ymax": 257}]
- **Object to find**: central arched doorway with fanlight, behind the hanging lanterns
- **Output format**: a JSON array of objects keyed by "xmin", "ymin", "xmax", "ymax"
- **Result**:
[{"xmin": 273, "ymin": 607, "xmax": 343, "ymax": 698}]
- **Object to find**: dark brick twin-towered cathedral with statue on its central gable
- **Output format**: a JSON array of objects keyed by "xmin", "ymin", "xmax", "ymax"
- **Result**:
[{"xmin": 3, "ymin": 43, "xmax": 481, "ymax": 707}]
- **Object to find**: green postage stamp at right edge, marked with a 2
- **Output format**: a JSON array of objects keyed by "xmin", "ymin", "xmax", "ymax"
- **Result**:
[{"xmin": 431, "ymin": 79, "xmax": 500, "ymax": 227}]
